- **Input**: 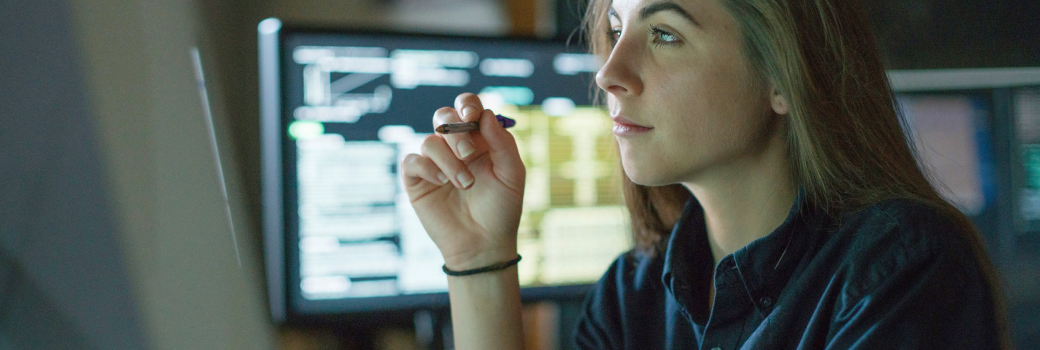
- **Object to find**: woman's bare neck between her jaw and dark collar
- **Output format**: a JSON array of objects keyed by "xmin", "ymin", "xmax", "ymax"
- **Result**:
[{"xmin": 683, "ymin": 129, "xmax": 798, "ymax": 265}]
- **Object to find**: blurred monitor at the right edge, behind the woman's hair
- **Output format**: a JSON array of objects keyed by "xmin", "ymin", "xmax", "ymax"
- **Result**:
[{"xmin": 889, "ymin": 68, "xmax": 1040, "ymax": 234}]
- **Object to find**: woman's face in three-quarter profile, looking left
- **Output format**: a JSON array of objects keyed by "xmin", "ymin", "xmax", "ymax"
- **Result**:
[{"xmin": 596, "ymin": 0, "xmax": 782, "ymax": 186}]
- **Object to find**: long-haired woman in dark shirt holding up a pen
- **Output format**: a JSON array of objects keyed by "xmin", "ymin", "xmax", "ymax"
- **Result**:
[{"xmin": 401, "ymin": 0, "xmax": 1007, "ymax": 349}]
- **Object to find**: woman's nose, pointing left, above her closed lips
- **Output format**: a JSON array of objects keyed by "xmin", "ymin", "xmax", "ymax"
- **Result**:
[{"xmin": 596, "ymin": 35, "xmax": 643, "ymax": 98}]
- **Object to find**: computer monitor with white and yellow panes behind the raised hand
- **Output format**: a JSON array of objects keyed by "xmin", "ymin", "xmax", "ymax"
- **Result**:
[{"xmin": 258, "ymin": 19, "xmax": 631, "ymax": 321}]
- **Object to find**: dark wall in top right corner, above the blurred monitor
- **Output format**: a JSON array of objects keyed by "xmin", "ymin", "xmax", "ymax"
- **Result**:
[{"xmin": 863, "ymin": 0, "xmax": 1040, "ymax": 70}]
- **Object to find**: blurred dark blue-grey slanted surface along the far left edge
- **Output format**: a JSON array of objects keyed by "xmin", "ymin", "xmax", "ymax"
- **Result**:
[{"xmin": 0, "ymin": 0, "xmax": 146, "ymax": 349}]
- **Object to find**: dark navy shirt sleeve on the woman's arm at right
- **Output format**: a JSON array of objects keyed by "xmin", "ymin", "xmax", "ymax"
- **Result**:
[{"xmin": 827, "ymin": 230, "xmax": 1000, "ymax": 349}]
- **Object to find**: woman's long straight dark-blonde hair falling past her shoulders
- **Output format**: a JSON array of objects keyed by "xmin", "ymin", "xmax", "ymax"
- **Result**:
[{"xmin": 584, "ymin": 0, "xmax": 1008, "ymax": 344}]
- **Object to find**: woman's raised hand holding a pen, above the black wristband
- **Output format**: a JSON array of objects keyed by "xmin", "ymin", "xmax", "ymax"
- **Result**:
[{"xmin": 400, "ymin": 93, "xmax": 525, "ymax": 270}]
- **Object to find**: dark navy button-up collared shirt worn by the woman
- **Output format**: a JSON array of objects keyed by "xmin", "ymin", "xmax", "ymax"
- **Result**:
[{"xmin": 575, "ymin": 194, "xmax": 999, "ymax": 349}]
